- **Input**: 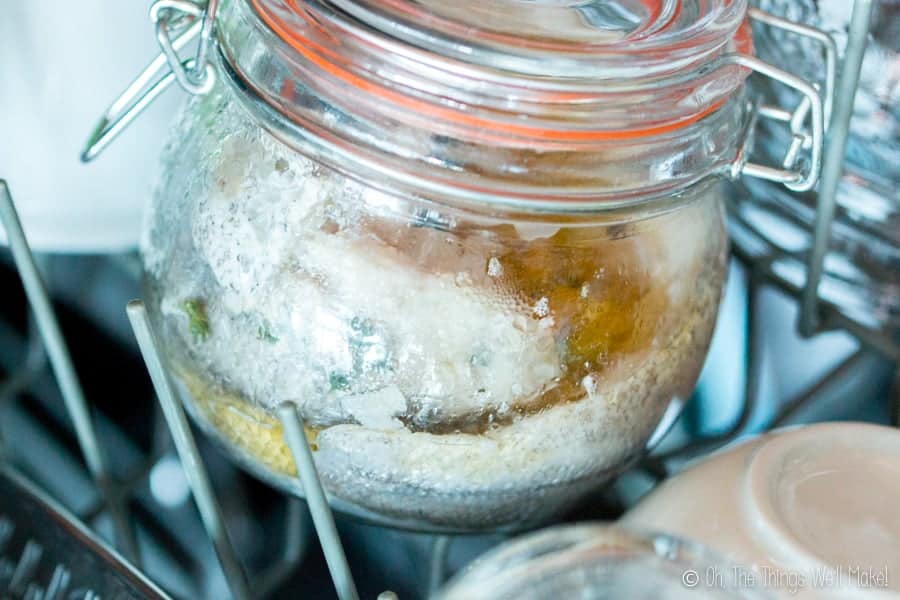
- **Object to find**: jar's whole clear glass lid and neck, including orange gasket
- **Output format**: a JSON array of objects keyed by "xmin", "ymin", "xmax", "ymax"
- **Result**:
[{"xmin": 217, "ymin": 0, "xmax": 750, "ymax": 210}]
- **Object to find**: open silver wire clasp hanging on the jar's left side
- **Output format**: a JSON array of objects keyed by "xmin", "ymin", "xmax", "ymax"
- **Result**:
[{"xmin": 81, "ymin": 0, "xmax": 219, "ymax": 162}]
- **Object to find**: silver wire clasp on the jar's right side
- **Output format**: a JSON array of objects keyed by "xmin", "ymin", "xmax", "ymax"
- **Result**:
[{"xmin": 736, "ymin": 8, "xmax": 837, "ymax": 192}]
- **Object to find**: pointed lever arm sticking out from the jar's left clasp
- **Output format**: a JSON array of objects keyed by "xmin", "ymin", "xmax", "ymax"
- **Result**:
[{"xmin": 81, "ymin": 12, "xmax": 203, "ymax": 162}]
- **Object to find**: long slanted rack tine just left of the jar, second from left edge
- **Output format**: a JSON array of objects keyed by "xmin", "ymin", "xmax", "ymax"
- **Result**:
[{"xmin": 128, "ymin": 300, "xmax": 251, "ymax": 600}]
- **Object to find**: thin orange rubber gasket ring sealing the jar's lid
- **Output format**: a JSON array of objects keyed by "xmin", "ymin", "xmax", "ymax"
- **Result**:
[{"xmin": 250, "ymin": 0, "xmax": 747, "ymax": 142}]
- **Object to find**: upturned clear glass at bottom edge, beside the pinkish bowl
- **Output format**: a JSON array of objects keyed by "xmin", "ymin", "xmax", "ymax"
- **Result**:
[{"xmin": 438, "ymin": 524, "xmax": 769, "ymax": 600}]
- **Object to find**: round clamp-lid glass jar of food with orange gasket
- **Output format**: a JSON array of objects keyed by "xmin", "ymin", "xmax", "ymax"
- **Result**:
[{"xmin": 135, "ymin": 0, "xmax": 821, "ymax": 530}]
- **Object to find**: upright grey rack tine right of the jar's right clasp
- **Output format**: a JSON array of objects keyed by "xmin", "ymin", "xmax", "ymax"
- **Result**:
[{"xmin": 798, "ymin": 0, "xmax": 874, "ymax": 336}]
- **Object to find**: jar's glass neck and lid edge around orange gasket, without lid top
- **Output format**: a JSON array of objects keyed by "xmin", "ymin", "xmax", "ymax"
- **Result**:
[{"xmin": 217, "ymin": 0, "xmax": 752, "ymax": 214}]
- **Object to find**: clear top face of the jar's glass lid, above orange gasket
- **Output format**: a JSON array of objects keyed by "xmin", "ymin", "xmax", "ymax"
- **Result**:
[{"xmin": 326, "ymin": 0, "xmax": 747, "ymax": 79}]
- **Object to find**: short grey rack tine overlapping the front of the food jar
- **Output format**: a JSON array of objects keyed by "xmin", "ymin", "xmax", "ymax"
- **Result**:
[{"xmin": 278, "ymin": 403, "xmax": 359, "ymax": 600}]
